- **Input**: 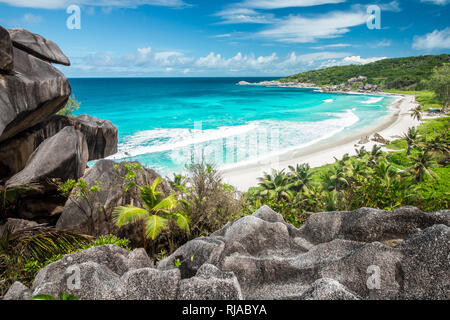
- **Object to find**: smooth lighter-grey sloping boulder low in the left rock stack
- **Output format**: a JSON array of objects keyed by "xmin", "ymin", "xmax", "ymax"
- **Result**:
[{"xmin": 6, "ymin": 127, "xmax": 88, "ymax": 187}]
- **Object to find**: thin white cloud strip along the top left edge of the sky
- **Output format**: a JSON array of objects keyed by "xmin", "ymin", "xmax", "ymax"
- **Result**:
[{"xmin": 0, "ymin": 0, "xmax": 186, "ymax": 9}]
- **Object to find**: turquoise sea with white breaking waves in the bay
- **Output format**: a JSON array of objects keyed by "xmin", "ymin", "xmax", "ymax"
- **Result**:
[{"xmin": 70, "ymin": 78, "xmax": 395, "ymax": 175}]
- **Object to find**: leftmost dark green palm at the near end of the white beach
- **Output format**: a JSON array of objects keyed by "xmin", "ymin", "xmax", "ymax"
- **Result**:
[{"xmin": 258, "ymin": 170, "xmax": 293, "ymax": 201}]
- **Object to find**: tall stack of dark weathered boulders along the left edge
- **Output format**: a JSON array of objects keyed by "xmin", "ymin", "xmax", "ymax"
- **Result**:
[{"xmin": 0, "ymin": 27, "xmax": 118, "ymax": 222}]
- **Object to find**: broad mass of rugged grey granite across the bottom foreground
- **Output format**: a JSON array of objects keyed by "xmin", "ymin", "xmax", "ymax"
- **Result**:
[{"xmin": 5, "ymin": 207, "xmax": 450, "ymax": 300}]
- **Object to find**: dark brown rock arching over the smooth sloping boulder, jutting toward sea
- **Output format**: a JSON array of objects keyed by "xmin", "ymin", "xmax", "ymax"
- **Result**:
[{"xmin": 0, "ymin": 115, "xmax": 118, "ymax": 179}]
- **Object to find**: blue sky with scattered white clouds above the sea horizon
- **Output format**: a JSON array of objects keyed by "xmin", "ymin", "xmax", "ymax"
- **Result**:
[{"xmin": 0, "ymin": 0, "xmax": 450, "ymax": 77}]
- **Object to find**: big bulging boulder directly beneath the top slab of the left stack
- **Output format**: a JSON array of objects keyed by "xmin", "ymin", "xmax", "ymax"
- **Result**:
[{"xmin": 0, "ymin": 48, "xmax": 71, "ymax": 143}]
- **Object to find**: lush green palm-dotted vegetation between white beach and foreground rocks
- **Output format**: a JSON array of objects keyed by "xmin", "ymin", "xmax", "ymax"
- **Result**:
[{"xmin": 244, "ymin": 113, "xmax": 450, "ymax": 226}]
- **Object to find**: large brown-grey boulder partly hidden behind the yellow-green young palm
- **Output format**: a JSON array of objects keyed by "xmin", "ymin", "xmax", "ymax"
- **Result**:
[{"xmin": 56, "ymin": 160, "xmax": 170, "ymax": 238}]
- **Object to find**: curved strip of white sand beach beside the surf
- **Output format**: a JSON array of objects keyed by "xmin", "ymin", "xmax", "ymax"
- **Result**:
[{"xmin": 221, "ymin": 95, "xmax": 420, "ymax": 191}]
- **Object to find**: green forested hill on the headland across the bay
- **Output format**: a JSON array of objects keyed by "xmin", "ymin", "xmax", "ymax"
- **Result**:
[{"xmin": 280, "ymin": 54, "xmax": 450, "ymax": 90}]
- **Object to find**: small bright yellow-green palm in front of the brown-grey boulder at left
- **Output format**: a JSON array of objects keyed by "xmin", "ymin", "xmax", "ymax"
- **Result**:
[{"xmin": 113, "ymin": 177, "xmax": 190, "ymax": 248}]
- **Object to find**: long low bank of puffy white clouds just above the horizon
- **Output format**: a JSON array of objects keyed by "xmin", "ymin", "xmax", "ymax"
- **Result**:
[{"xmin": 64, "ymin": 47, "xmax": 390, "ymax": 76}]
